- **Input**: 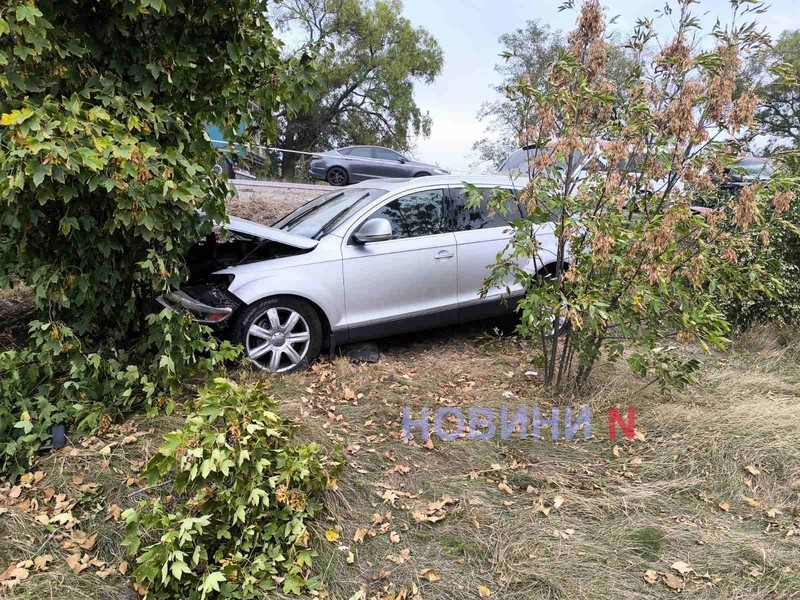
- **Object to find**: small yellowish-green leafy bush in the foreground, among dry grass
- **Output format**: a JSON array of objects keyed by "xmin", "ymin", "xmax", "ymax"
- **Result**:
[{"xmin": 124, "ymin": 379, "xmax": 338, "ymax": 600}]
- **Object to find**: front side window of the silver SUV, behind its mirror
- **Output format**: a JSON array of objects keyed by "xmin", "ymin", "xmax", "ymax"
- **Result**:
[{"xmin": 369, "ymin": 190, "xmax": 450, "ymax": 240}]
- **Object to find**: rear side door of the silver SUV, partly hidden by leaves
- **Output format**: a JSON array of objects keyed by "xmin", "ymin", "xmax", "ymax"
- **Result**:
[{"xmin": 450, "ymin": 186, "xmax": 550, "ymax": 321}]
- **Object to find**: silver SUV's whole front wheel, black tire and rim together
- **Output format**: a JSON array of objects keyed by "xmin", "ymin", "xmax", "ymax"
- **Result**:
[{"xmin": 231, "ymin": 296, "xmax": 322, "ymax": 373}]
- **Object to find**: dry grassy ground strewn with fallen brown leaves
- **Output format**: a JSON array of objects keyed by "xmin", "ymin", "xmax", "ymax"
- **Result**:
[{"xmin": 0, "ymin": 325, "xmax": 800, "ymax": 600}]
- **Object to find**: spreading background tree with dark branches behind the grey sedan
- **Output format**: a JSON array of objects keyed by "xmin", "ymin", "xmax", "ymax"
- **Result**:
[{"xmin": 278, "ymin": 0, "xmax": 443, "ymax": 178}]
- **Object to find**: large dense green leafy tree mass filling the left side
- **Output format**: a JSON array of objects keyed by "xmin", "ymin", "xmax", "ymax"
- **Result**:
[{"xmin": 0, "ymin": 0, "xmax": 308, "ymax": 474}]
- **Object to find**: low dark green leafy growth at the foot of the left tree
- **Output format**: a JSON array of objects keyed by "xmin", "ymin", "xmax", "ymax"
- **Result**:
[{"xmin": 0, "ymin": 311, "xmax": 237, "ymax": 476}]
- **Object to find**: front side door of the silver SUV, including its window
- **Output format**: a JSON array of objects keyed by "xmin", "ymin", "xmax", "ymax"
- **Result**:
[{"xmin": 342, "ymin": 188, "xmax": 458, "ymax": 341}]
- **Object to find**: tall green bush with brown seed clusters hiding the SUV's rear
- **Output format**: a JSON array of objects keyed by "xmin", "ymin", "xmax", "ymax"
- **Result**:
[{"xmin": 478, "ymin": 0, "xmax": 798, "ymax": 387}]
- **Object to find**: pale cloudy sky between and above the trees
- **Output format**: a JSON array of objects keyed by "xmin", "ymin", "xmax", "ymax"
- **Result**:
[{"xmin": 403, "ymin": 0, "xmax": 800, "ymax": 174}]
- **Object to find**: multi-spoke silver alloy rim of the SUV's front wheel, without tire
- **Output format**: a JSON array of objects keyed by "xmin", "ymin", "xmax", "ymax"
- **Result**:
[{"xmin": 245, "ymin": 307, "xmax": 311, "ymax": 373}]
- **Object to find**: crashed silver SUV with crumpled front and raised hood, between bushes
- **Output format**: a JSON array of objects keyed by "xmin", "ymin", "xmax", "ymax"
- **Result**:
[{"xmin": 160, "ymin": 176, "xmax": 556, "ymax": 372}]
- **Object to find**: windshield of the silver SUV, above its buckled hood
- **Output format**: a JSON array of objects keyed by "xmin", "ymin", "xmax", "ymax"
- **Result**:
[{"xmin": 272, "ymin": 188, "xmax": 386, "ymax": 238}]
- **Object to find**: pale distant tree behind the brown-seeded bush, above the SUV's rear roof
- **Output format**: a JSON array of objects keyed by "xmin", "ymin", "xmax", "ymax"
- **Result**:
[{"xmin": 472, "ymin": 19, "xmax": 635, "ymax": 169}]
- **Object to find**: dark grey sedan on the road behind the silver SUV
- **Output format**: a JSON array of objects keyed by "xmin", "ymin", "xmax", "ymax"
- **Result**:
[{"xmin": 308, "ymin": 146, "xmax": 448, "ymax": 186}]
